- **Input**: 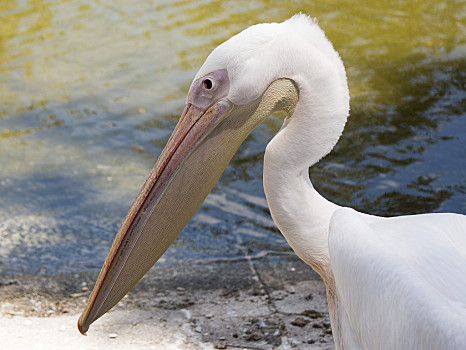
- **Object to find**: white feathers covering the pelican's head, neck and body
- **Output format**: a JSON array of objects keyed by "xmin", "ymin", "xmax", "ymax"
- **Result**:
[{"xmin": 200, "ymin": 15, "xmax": 466, "ymax": 350}]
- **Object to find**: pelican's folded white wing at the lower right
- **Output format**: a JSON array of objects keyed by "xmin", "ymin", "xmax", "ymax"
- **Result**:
[{"xmin": 329, "ymin": 208, "xmax": 466, "ymax": 349}]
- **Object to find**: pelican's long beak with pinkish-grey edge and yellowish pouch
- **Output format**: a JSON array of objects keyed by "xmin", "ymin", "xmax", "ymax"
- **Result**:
[{"xmin": 78, "ymin": 80, "xmax": 294, "ymax": 334}]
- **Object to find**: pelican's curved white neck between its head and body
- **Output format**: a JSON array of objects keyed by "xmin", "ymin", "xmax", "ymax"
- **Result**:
[{"xmin": 264, "ymin": 70, "xmax": 349, "ymax": 282}]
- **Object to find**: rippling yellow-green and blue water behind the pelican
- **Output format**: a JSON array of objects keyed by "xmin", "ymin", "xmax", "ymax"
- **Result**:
[{"xmin": 0, "ymin": 0, "xmax": 466, "ymax": 274}]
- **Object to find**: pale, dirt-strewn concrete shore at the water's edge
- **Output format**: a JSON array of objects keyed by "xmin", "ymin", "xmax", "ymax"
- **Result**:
[{"xmin": 0, "ymin": 255, "xmax": 334, "ymax": 350}]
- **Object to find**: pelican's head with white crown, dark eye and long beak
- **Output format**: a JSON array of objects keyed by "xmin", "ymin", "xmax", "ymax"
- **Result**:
[{"xmin": 78, "ymin": 15, "xmax": 348, "ymax": 334}]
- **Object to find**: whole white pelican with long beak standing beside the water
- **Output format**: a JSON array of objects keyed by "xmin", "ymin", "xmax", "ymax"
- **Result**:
[{"xmin": 78, "ymin": 14, "xmax": 466, "ymax": 349}]
